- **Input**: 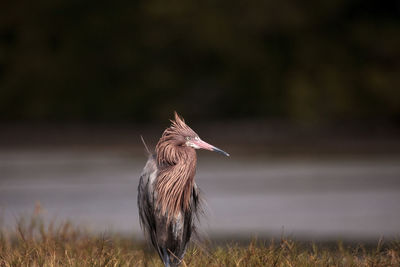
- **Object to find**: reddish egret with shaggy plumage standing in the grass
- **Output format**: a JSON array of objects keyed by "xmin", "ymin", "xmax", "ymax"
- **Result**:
[{"xmin": 137, "ymin": 112, "xmax": 229, "ymax": 267}]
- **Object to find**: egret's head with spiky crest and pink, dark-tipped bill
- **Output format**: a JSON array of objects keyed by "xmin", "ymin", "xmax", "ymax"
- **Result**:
[{"xmin": 157, "ymin": 112, "xmax": 229, "ymax": 162}]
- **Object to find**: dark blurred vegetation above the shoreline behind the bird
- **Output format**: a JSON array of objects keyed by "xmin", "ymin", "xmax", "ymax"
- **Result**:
[{"xmin": 0, "ymin": 0, "xmax": 400, "ymax": 124}]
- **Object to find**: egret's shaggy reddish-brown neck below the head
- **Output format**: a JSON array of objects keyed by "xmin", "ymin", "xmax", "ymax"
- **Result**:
[{"xmin": 156, "ymin": 147, "xmax": 197, "ymax": 221}]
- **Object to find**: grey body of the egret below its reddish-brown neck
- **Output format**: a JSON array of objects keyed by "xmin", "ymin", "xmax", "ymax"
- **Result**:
[{"xmin": 138, "ymin": 155, "xmax": 199, "ymax": 266}]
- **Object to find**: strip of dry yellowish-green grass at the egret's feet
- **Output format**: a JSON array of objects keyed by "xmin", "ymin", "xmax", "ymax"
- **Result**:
[{"xmin": 0, "ymin": 216, "xmax": 400, "ymax": 266}]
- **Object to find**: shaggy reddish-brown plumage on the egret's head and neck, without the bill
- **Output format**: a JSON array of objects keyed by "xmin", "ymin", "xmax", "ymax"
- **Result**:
[{"xmin": 156, "ymin": 112, "xmax": 197, "ymax": 220}]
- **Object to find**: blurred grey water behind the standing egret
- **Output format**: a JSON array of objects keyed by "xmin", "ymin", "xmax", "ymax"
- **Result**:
[{"xmin": 0, "ymin": 149, "xmax": 400, "ymax": 242}]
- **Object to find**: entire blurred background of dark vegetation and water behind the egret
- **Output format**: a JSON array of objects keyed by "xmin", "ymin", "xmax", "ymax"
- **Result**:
[{"xmin": 0, "ymin": 0, "xmax": 400, "ymax": 243}]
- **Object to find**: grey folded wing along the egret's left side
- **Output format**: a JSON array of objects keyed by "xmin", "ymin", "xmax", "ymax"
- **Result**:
[{"xmin": 137, "ymin": 155, "xmax": 162, "ymax": 257}]
